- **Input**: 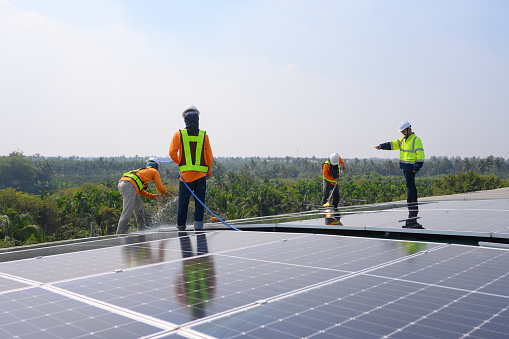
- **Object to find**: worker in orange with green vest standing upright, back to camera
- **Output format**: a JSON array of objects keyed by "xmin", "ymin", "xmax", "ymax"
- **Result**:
[{"xmin": 170, "ymin": 105, "xmax": 213, "ymax": 231}]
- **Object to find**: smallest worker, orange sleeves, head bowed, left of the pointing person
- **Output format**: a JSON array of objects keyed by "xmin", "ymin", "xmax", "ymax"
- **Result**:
[{"xmin": 322, "ymin": 153, "xmax": 346, "ymax": 226}]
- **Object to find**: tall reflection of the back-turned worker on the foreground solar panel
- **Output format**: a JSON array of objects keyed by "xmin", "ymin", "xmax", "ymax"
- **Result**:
[{"xmin": 175, "ymin": 232, "xmax": 216, "ymax": 319}]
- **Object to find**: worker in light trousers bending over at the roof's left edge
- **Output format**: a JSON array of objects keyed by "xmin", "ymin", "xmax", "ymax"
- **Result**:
[{"xmin": 117, "ymin": 157, "xmax": 171, "ymax": 234}]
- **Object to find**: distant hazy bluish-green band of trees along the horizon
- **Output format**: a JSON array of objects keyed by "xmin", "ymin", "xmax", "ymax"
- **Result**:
[{"xmin": 0, "ymin": 151, "xmax": 509, "ymax": 194}]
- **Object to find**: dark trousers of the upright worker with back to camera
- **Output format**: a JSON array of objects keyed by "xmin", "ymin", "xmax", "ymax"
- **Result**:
[{"xmin": 177, "ymin": 177, "xmax": 207, "ymax": 231}]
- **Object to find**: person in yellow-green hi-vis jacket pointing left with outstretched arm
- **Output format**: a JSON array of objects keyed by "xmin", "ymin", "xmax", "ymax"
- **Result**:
[{"xmin": 375, "ymin": 121, "xmax": 424, "ymax": 228}]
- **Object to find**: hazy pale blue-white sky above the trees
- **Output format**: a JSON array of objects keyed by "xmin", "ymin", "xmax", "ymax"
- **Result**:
[{"xmin": 0, "ymin": 0, "xmax": 509, "ymax": 159}]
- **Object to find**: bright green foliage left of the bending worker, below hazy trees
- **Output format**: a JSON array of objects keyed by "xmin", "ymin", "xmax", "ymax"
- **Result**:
[{"xmin": 0, "ymin": 184, "xmax": 126, "ymax": 243}]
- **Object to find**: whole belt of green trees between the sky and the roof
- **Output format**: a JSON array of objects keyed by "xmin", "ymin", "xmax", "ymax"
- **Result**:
[{"xmin": 0, "ymin": 152, "xmax": 509, "ymax": 247}]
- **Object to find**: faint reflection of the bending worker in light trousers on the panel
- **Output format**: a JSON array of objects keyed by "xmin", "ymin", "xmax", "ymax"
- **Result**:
[{"xmin": 122, "ymin": 234, "xmax": 167, "ymax": 267}]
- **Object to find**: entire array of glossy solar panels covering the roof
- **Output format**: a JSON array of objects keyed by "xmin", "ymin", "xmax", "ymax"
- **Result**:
[{"xmin": 0, "ymin": 187, "xmax": 509, "ymax": 338}]
